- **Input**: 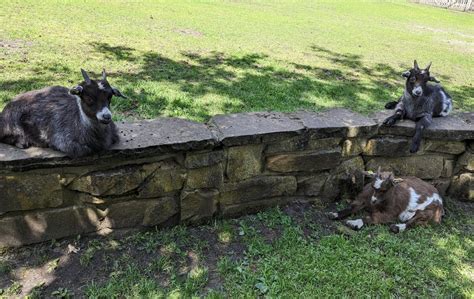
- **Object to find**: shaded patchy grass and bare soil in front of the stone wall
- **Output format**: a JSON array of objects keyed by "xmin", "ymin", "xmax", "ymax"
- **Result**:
[{"xmin": 0, "ymin": 201, "xmax": 474, "ymax": 298}]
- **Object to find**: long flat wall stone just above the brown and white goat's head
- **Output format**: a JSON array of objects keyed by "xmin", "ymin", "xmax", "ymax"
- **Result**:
[{"xmin": 366, "ymin": 155, "xmax": 444, "ymax": 179}]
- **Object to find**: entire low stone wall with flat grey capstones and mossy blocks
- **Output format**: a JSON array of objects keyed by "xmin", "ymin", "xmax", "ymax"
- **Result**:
[{"xmin": 0, "ymin": 109, "xmax": 474, "ymax": 246}]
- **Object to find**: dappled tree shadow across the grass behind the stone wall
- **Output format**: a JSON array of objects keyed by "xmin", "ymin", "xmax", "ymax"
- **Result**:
[{"xmin": 0, "ymin": 42, "xmax": 473, "ymax": 121}]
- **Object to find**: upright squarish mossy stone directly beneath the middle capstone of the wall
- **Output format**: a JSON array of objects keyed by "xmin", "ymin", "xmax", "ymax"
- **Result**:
[{"xmin": 226, "ymin": 144, "xmax": 263, "ymax": 181}]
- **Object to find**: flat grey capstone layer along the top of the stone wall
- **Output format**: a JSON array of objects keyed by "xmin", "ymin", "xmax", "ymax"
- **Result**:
[{"xmin": 0, "ymin": 109, "xmax": 474, "ymax": 169}]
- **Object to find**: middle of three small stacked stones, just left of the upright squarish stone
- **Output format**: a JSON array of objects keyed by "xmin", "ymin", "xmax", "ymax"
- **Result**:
[{"xmin": 185, "ymin": 164, "xmax": 224, "ymax": 189}]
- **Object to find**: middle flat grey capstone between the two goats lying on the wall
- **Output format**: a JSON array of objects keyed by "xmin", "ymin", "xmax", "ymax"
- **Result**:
[{"xmin": 210, "ymin": 112, "xmax": 304, "ymax": 146}]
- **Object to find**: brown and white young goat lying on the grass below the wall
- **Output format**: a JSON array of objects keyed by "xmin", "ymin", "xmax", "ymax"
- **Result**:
[{"xmin": 328, "ymin": 168, "xmax": 444, "ymax": 233}]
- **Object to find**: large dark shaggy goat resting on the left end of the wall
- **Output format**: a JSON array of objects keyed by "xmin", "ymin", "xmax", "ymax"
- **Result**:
[{"xmin": 0, "ymin": 69, "xmax": 126, "ymax": 158}]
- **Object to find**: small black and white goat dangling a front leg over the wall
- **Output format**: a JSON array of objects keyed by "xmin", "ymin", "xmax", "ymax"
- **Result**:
[{"xmin": 383, "ymin": 60, "xmax": 453, "ymax": 153}]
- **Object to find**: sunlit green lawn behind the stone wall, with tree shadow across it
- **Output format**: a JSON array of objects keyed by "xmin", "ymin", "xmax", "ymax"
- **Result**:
[{"xmin": 0, "ymin": 0, "xmax": 474, "ymax": 121}]
